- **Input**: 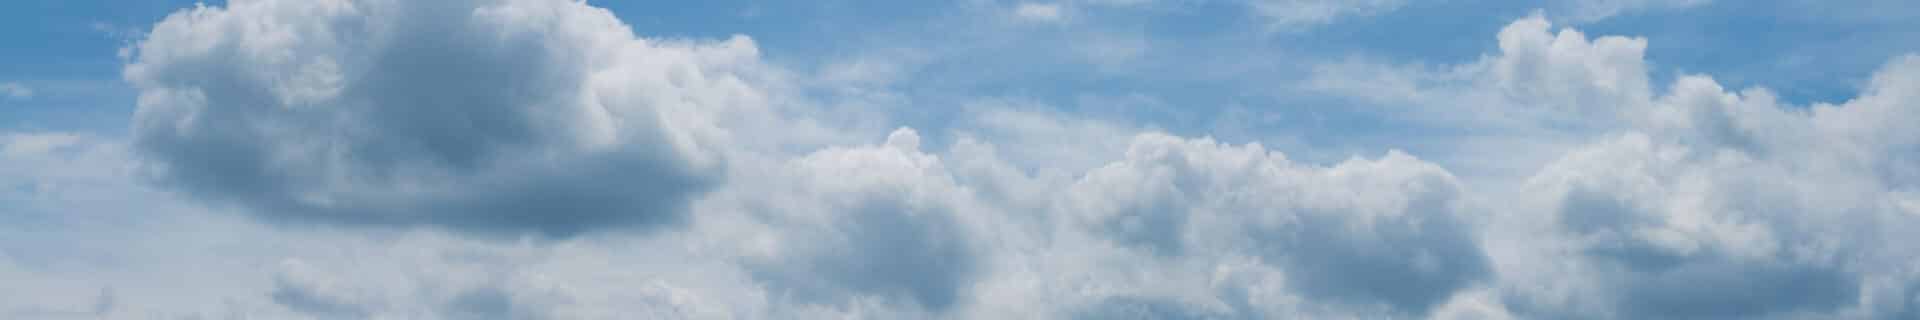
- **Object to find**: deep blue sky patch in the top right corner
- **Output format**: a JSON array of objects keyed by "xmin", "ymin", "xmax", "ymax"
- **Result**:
[{"xmin": 1580, "ymin": 0, "xmax": 1920, "ymax": 105}]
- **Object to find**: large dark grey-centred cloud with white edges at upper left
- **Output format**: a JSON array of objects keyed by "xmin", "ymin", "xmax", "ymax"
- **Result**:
[{"xmin": 125, "ymin": 0, "xmax": 766, "ymax": 236}]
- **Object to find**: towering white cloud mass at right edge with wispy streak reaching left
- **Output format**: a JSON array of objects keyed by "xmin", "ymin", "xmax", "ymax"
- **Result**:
[{"xmin": 1309, "ymin": 15, "xmax": 1920, "ymax": 318}]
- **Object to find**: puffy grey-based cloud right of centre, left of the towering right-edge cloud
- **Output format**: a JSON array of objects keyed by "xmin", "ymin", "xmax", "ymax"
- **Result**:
[{"xmin": 1062, "ymin": 134, "xmax": 1490, "ymax": 314}]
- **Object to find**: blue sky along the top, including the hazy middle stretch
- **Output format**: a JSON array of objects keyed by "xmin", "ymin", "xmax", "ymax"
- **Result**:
[{"xmin": 0, "ymin": 0, "xmax": 1920, "ymax": 168}]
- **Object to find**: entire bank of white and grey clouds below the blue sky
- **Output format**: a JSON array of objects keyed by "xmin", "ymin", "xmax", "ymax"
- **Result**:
[{"xmin": 0, "ymin": 0, "xmax": 1920, "ymax": 320}]
